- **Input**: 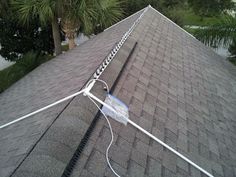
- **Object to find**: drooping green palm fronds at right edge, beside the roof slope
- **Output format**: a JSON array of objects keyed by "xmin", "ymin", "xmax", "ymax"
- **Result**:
[{"xmin": 195, "ymin": 16, "xmax": 236, "ymax": 47}]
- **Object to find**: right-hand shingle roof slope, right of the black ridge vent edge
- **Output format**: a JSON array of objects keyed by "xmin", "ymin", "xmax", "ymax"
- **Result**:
[{"xmin": 72, "ymin": 8, "xmax": 236, "ymax": 177}]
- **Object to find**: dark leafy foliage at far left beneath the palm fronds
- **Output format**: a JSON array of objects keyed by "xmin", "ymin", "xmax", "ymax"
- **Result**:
[{"xmin": 0, "ymin": 0, "xmax": 53, "ymax": 61}]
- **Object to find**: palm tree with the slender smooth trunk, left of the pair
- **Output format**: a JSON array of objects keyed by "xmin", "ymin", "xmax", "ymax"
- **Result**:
[{"xmin": 11, "ymin": 0, "xmax": 62, "ymax": 55}]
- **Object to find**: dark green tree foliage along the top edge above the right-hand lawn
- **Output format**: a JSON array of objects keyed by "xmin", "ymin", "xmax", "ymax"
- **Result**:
[{"xmin": 188, "ymin": 0, "xmax": 233, "ymax": 17}]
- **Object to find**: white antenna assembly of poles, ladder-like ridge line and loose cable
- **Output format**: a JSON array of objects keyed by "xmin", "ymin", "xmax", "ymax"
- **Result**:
[{"xmin": 0, "ymin": 6, "xmax": 214, "ymax": 177}]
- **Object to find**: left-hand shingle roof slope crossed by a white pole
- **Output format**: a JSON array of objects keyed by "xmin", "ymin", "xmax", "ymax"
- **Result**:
[{"xmin": 0, "ymin": 12, "xmax": 143, "ymax": 177}]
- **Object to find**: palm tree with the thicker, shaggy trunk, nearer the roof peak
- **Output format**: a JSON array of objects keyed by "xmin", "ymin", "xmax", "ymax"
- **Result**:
[{"xmin": 61, "ymin": 0, "xmax": 123, "ymax": 49}]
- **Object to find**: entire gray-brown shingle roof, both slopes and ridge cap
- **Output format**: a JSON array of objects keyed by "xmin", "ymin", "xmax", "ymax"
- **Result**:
[{"xmin": 0, "ymin": 7, "xmax": 236, "ymax": 177}]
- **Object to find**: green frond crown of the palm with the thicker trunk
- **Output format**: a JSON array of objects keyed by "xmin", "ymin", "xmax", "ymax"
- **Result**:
[{"xmin": 62, "ymin": 0, "xmax": 123, "ymax": 34}]
